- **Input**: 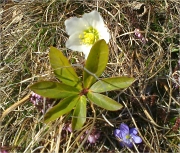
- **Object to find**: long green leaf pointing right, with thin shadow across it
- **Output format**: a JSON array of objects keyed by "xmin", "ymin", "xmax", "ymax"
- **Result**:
[{"xmin": 90, "ymin": 77, "xmax": 134, "ymax": 93}]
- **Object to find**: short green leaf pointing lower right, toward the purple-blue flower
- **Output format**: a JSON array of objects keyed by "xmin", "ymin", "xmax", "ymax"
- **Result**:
[{"xmin": 87, "ymin": 92, "xmax": 123, "ymax": 111}]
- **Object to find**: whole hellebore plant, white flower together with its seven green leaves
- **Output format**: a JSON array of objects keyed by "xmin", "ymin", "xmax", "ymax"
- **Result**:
[{"xmin": 30, "ymin": 11, "xmax": 134, "ymax": 130}]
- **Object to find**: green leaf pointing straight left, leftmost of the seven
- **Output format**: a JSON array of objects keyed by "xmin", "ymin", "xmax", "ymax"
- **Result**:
[{"xmin": 30, "ymin": 81, "xmax": 79, "ymax": 99}]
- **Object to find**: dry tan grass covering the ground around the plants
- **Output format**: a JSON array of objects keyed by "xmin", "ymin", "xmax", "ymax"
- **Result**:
[{"xmin": 0, "ymin": 0, "xmax": 180, "ymax": 152}]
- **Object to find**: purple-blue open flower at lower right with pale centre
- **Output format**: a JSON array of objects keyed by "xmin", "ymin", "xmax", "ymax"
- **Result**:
[{"xmin": 114, "ymin": 123, "xmax": 142, "ymax": 148}]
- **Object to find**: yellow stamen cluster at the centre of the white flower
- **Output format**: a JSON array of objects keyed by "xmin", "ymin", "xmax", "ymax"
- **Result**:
[{"xmin": 79, "ymin": 27, "xmax": 99, "ymax": 45}]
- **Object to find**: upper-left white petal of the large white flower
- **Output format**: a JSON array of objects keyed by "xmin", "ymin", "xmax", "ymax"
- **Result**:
[{"xmin": 65, "ymin": 17, "xmax": 89, "ymax": 35}]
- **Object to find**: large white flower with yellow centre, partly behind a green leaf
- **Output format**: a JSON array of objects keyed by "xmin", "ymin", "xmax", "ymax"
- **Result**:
[{"xmin": 65, "ymin": 10, "xmax": 110, "ymax": 59}]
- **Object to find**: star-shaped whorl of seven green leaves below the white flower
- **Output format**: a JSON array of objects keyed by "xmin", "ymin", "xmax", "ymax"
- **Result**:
[{"xmin": 30, "ymin": 40, "xmax": 134, "ymax": 130}]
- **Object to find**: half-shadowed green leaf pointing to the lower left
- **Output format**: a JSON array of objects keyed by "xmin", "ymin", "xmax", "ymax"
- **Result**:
[{"xmin": 44, "ymin": 95, "xmax": 79, "ymax": 123}]
